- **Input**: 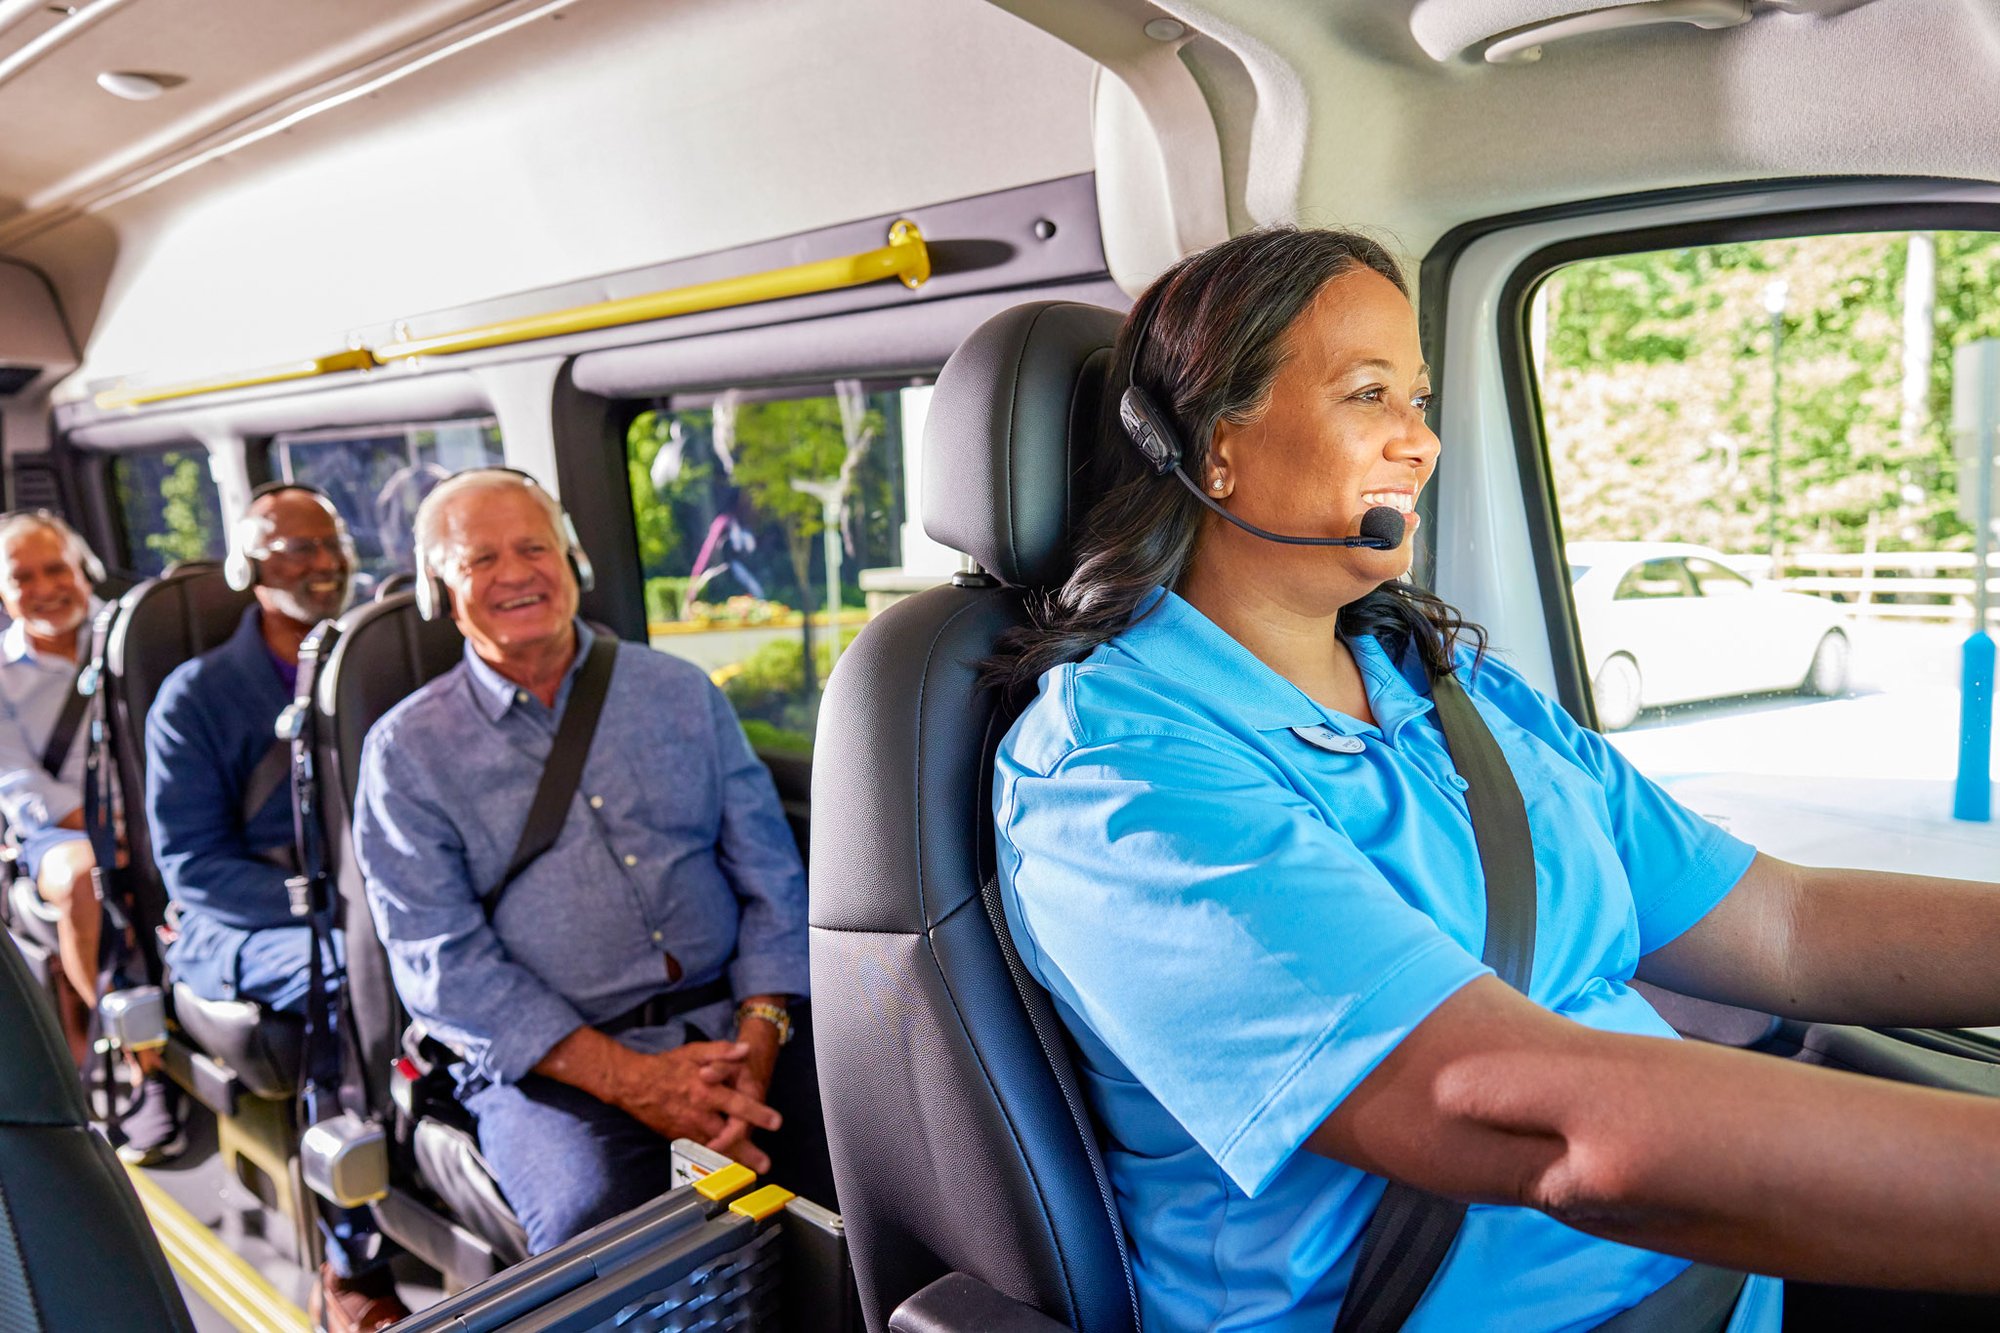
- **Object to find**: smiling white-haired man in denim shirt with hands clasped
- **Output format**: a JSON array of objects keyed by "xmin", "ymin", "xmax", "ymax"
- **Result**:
[{"xmin": 354, "ymin": 468, "xmax": 810, "ymax": 1253}]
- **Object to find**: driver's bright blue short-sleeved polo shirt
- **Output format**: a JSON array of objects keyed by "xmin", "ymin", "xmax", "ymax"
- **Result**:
[{"xmin": 994, "ymin": 592, "xmax": 1782, "ymax": 1333}]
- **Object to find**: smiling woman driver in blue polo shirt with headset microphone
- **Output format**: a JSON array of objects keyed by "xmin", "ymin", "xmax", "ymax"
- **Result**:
[{"xmin": 988, "ymin": 228, "xmax": 2000, "ymax": 1331}]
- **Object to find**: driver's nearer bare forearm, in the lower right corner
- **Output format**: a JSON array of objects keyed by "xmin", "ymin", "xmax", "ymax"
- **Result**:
[{"xmin": 1538, "ymin": 1012, "xmax": 2000, "ymax": 1291}]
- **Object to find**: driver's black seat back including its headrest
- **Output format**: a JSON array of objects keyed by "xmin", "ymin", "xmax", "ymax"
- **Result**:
[{"xmin": 808, "ymin": 302, "xmax": 1138, "ymax": 1333}]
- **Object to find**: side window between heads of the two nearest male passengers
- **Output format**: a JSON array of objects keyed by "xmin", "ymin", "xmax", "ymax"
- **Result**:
[{"xmin": 270, "ymin": 416, "xmax": 506, "ymax": 596}]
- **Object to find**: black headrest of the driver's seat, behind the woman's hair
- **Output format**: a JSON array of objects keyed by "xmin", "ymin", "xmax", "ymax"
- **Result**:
[{"xmin": 924, "ymin": 300, "xmax": 1124, "ymax": 586}]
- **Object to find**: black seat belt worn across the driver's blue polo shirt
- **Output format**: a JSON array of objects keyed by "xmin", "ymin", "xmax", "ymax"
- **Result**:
[{"xmin": 1334, "ymin": 675, "xmax": 1744, "ymax": 1333}]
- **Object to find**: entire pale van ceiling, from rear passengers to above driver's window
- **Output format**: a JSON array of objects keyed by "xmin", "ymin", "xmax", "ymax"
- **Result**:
[{"xmin": 0, "ymin": 0, "xmax": 2000, "ymax": 426}]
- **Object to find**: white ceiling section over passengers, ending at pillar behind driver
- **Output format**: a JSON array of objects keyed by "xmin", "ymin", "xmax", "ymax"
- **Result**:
[{"xmin": 0, "ymin": 0, "xmax": 1092, "ymax": 394}]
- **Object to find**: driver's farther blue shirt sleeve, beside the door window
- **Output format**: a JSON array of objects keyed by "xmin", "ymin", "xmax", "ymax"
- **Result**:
[{"xmin": 1474, "ymin": 658, "xmax": 1756, "ymax": 955}]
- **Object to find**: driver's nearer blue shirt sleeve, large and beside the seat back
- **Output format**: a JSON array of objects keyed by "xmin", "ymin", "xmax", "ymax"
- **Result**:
[{"xmin": 996, "ymin": 716, "xmax": 1490, "ymax": 1195}]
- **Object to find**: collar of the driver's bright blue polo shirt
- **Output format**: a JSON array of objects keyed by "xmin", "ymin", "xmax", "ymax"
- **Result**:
[{"xmin": 1108, "ymin": 588, "xmax": 1432, "ymax": 737}]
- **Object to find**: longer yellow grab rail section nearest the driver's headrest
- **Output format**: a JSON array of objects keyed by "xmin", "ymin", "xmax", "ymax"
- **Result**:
[{"xmin": 374, "ymin": 218, "xmax": 930, "ymax": 362}]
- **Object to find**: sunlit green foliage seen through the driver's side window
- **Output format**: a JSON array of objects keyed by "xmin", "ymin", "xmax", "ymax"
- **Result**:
[{"xmin": 1538, "ymin": 232, "xmax": 2000, "ymax": 552}]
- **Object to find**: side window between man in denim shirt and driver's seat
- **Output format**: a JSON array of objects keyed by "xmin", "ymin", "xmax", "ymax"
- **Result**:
[{"xmin": 626, "ymin": 380, "xmax": 936, "ymax": 755}]
